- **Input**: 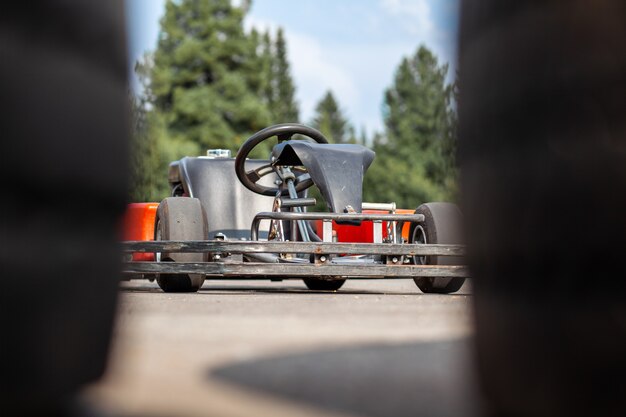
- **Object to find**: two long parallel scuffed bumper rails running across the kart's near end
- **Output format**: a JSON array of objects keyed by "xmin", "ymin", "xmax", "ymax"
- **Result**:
[{"xmin": 122, "ymin": 240, "xmax": 468, "ymax": 279}]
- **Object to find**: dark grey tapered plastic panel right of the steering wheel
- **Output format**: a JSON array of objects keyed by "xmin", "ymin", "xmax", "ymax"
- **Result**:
[{"xmin": 272, "ymin": 140, "xmax": 376, "ymax": 213}]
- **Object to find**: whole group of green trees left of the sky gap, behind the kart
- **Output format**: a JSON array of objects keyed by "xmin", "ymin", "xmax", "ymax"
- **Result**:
[{"xmin": 131, "ymin": 0, "xmax": 298, "ymax": 201}]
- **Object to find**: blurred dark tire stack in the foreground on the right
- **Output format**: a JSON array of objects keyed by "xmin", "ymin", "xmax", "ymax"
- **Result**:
[{"xmin": 459, "ymin": 0, "xmax": 626, "ymax": 416}]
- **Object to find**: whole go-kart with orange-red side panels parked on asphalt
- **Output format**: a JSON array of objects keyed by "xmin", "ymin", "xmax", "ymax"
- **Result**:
[{"xmin": 123, "ymin": 123, "xmax": 467, "ymax": 293}]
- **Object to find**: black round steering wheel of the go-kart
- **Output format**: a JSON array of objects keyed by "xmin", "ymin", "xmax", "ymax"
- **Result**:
[{"xmin": 235, "ymin": 123, "xmax": 328, "ymax": 197}]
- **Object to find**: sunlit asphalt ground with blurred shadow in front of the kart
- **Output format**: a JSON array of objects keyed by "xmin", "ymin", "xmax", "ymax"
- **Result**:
[{"xmin": 84, "ymin": 280, "xmax": 478, "ymax": 417}]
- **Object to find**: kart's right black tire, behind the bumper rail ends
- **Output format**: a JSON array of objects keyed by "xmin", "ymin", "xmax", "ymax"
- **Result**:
[{"xmin": 409, "ymin": 203, "xmax": 465, "ymax": 294}]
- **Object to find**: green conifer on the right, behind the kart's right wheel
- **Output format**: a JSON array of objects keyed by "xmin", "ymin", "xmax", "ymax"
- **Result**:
[{"xmin": 364, "ymin": 46, "xmax": 456, "ymax": 207}]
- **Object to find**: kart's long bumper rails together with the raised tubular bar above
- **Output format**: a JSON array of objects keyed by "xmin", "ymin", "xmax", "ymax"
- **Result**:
[{"xmin": 122, "ymin": 212, "xmax": 468, "ymax": 280}]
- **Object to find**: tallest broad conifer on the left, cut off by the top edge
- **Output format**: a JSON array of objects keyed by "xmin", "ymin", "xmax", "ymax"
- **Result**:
[{"xmin": 151, "ymin": 0, "xmax": 270, "ymax": 151}]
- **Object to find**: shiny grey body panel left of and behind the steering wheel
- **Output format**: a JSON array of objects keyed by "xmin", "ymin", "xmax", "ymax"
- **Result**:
[{"xmin": 169, "ymin": 157, "xmax": 278, "ymax": 239}]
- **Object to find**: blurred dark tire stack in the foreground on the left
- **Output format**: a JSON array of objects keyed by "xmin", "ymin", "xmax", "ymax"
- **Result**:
[{"xmin": 0, "ymin": 0, "xmax": 128, "ymax": 416}]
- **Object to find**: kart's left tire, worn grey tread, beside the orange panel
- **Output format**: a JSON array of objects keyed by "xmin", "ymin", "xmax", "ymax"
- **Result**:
[{"xmin": 154, "ymin": 197, "xmax": 208, "ymax": 292}]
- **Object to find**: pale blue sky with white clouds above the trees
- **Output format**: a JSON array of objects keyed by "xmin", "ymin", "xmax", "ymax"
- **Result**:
[{"xmin": 126, "ymin": 0, "xmax": 458, "ymax": 137}]
